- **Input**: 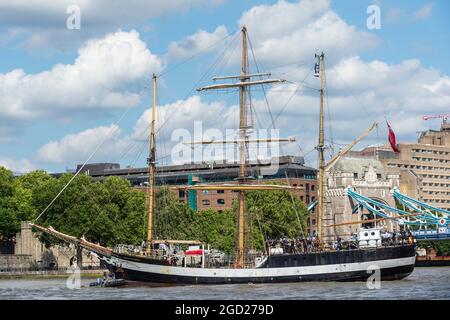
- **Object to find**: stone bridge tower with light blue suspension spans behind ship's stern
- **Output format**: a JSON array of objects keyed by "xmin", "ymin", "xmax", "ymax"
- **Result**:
[{"xmin": 316, "ymin": 157, "xmax": 450, "ymax": 242}]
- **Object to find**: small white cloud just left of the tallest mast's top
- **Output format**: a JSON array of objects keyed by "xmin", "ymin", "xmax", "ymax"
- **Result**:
[{"xmin": 167, "ymin": 26, "xmax": 228, "ymax": 60}]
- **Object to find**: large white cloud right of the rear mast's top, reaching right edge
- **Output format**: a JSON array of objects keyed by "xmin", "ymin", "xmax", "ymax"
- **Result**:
[{"xmin": 329, "ymin": 57, "xmax": 450, "ymax": 113}]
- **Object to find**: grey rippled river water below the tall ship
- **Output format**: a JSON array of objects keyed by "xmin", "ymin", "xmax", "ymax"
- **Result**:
[{"xmin": 0, "ymin": 267, "xmax": 450, "ymax": 300}]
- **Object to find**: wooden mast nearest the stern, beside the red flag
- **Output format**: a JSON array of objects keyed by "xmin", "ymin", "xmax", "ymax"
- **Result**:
[{"xmin": 316, "ymin": 52, "xmax": 325, "ymax": 243}]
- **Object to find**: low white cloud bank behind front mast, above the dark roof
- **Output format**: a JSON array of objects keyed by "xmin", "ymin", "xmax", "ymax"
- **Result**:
[{"xmin": 36, "ymin": 96, "xmax": 237, "ymax": 166}]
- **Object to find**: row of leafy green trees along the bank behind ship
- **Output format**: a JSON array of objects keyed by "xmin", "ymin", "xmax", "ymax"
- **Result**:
[{"xmin": 0, "ymin": 168, "xmax": 307, "ymax": 253}]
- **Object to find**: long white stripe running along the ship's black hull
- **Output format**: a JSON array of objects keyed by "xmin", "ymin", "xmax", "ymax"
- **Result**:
[{"xmin": 110, "ymin": 256, "xmax": 415, "ymax": 278}]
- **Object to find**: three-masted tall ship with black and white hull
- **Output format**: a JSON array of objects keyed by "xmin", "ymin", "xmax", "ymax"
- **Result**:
[{"xmin": 33, "ymin": 27, "xmax": 415, "ymax": 284}]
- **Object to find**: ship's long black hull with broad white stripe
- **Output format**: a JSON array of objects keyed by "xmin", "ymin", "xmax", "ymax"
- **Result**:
[{"xmin": 107, "ymin": 246, "xmax": 415, "ymax": 284}]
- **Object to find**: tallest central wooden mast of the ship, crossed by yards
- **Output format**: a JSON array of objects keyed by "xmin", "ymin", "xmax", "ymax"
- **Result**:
[{"xmin": 236, "ymin": 26, "xmax": 247, "ymax": 268}]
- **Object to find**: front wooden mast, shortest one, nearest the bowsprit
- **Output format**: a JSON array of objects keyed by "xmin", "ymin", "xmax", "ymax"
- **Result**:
[{"xmin": 146, "ymin": 74, "xmax": 156, "ymax": 255}]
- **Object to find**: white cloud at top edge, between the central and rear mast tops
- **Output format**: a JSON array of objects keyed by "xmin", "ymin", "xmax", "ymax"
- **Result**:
[{"xmin": 238, "ymin": 0, "xmax": 378, "ymax": 64}]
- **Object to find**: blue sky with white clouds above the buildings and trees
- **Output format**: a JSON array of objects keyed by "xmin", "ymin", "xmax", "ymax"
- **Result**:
[{"xmin": 0, "ymin": 0, "xmax": 450, "ymax": 172}]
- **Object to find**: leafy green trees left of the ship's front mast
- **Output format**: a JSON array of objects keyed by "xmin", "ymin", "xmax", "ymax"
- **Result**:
[{"xmin": 0, "ymin": 168, "xmax": 145, "ymax": 246}]
